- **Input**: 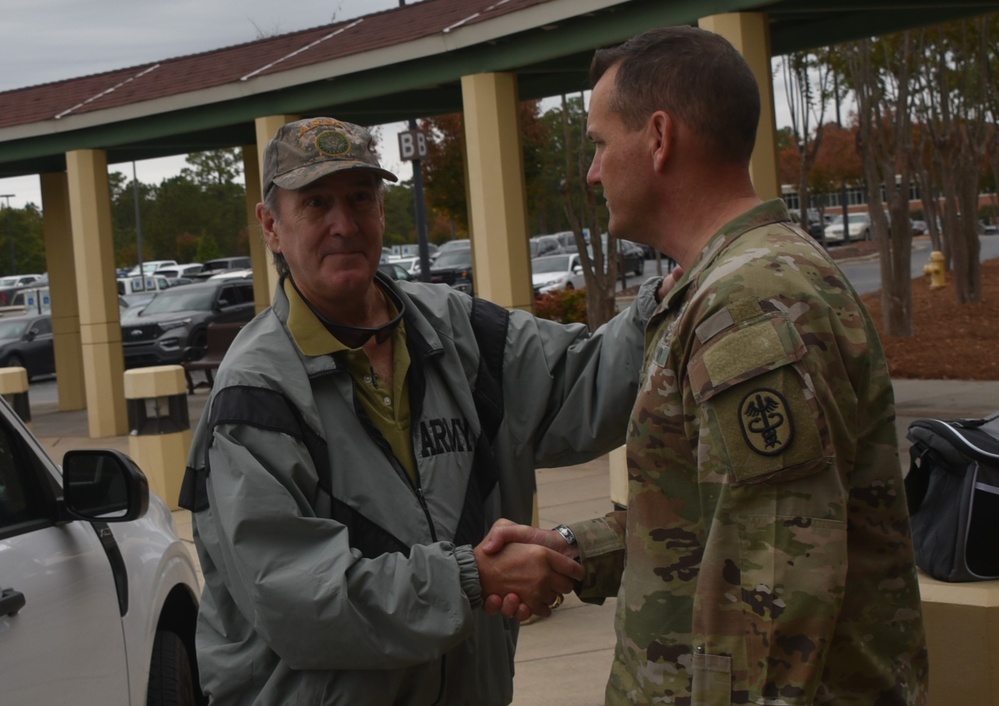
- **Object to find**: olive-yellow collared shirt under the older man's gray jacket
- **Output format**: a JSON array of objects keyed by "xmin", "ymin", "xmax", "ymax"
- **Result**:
[{"xmin": 284, "ymin": 279, "xmax": 418, "ymax": 486}]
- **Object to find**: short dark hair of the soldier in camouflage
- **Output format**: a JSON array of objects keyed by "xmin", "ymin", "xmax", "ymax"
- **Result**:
[{"xmin": 590, "ymin": 26, "xmax": 760, "ymax": 164}]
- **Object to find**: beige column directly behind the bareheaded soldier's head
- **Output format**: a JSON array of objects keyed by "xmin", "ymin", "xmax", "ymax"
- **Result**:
[{"xmin": 697, "ymin": 12, "xmax": 781, "ymax": 199}]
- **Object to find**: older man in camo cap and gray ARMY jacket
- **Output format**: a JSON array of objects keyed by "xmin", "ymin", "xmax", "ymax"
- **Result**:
[{"xmin": 185, "ymin": 118, "xmax": 658, "ymax": 706}]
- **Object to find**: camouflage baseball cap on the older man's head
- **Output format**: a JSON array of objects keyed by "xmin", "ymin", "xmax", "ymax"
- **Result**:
[{"xmin": 264, "ymin": 118, "xmax": 399, "ymax": 194}]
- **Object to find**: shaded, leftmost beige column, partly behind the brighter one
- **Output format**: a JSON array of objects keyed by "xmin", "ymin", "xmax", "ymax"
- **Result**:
[{"xmin": 41, "ymin": 172, "xmax": 87, "ymax": 411}]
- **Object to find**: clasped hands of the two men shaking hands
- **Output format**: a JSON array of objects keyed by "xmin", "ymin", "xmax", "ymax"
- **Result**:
[{"xmin": 474, "ymin": 520, "xmax": 583, "ymax": 621}]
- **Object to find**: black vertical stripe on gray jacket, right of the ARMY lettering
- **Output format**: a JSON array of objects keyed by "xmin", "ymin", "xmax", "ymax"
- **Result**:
[{"xmin": 454, "ymin": 298, "xmax": 510, "ymax": 546}]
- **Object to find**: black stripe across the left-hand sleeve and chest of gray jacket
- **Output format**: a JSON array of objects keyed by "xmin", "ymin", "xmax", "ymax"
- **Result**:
[{"xmin": 180, "ymin": 385, "xmax": 409, "ymax": 558}]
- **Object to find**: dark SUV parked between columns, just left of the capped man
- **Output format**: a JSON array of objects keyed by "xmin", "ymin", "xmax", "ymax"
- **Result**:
[{"xmin": 121, "ymin": 280, "xmax": 256, "ymax": 368}]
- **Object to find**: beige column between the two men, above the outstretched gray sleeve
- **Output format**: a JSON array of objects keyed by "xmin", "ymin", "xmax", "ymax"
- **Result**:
[{"xmin": 461, "ymin": 73, "xmax": 534, "ymax": 311}]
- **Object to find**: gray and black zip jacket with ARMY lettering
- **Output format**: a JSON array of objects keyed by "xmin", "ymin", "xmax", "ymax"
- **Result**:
[{"xmin": 184, "ymin": 272, "xmax": 659, "ymax": 706}]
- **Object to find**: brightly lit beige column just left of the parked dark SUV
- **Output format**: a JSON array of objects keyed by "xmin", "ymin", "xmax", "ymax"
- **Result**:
[{"xmin": 66, "ymin": 150, "xmax": 128, "ymax": 438}]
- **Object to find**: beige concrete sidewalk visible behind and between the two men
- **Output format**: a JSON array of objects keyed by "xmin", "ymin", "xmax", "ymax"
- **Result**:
[{"xmin": 21, "ymin": 380, "xmax": 999, "ymax": 706}]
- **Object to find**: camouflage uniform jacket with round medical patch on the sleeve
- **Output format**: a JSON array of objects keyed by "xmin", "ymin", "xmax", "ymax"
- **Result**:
[{"xmin": 572, "ymin": 201, "xmax": 927, "ymax": 706}]
